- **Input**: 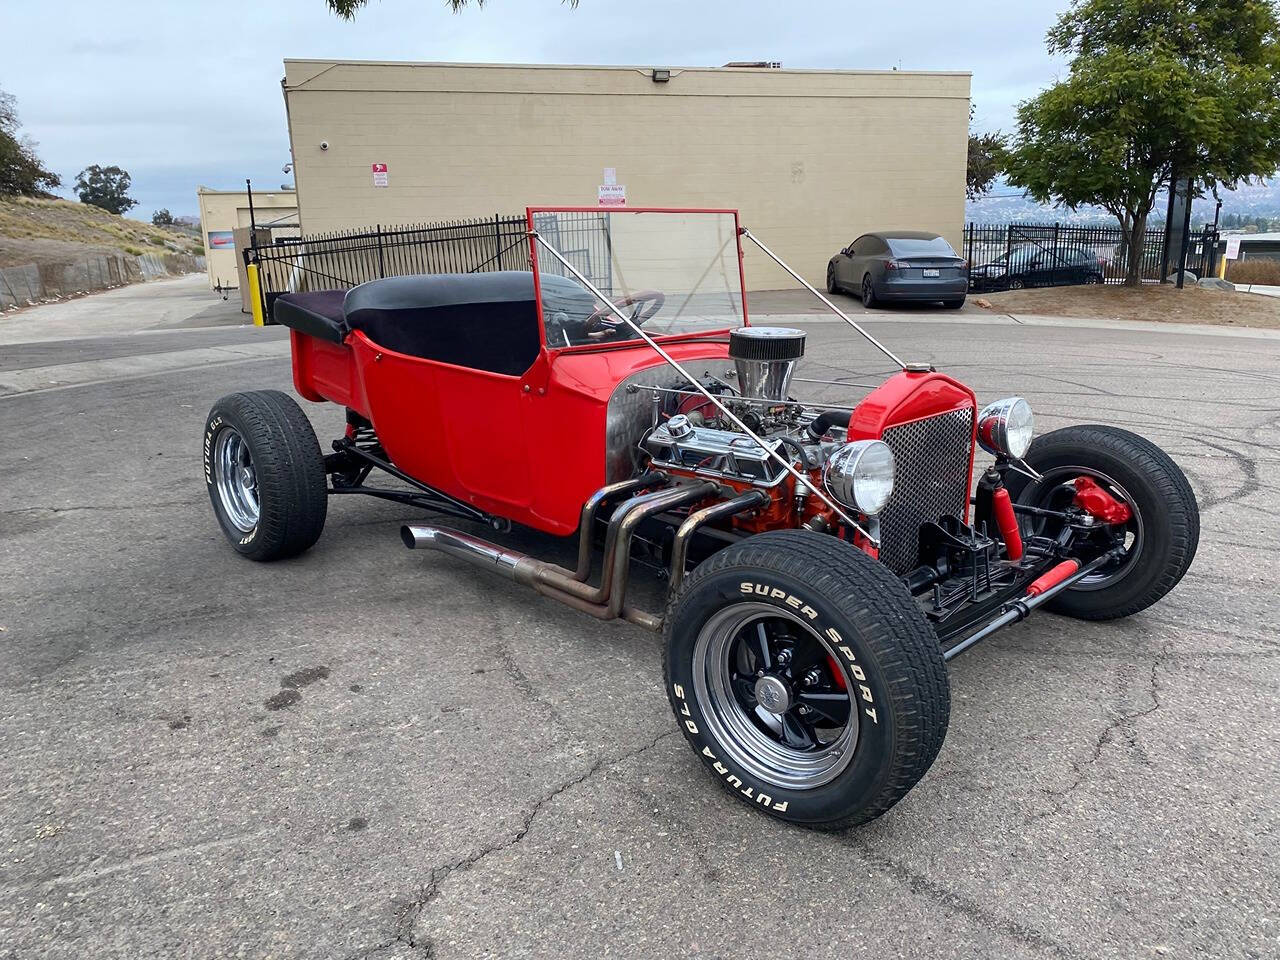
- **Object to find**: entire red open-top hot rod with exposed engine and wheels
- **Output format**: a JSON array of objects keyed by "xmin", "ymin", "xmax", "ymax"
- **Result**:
[{"xmin": 204, "ymin": 209, "xmax": 1199, "ymax": 828}]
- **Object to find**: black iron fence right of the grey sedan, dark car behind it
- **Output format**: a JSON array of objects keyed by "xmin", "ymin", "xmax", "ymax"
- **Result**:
[{"xmin": 964, "ymin": 223, "xmax": 1217, "ymax": 292}]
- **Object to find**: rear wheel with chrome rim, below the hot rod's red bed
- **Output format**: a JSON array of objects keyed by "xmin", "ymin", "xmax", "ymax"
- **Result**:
[{"xmin": 204, "ymin": 390, "xmax": 329, "ymax": 561}]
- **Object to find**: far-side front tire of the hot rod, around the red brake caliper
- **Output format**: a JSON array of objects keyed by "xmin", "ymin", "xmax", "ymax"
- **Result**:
[{"xmin": 1007, "ymin": 424, "xmax": 1199, "ymax": 620}]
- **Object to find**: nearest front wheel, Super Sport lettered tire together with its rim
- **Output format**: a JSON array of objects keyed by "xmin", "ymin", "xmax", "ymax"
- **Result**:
[{"xmin": 663, "ymin": 530, "xmax": 951, "ymax": 829}]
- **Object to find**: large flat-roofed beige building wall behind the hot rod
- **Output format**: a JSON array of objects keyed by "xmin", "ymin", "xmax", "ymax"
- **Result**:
[{"xmin": 277, "ymin": 60, "xmax": 969, "ymax": 289}]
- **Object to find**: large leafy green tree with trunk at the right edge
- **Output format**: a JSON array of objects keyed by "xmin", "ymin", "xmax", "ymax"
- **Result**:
[{"xmin": 1005, "ymin": 0, "xmax": 1280, "ymax": 285}]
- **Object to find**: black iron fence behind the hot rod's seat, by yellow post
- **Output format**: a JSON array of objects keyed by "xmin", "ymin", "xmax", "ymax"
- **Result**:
[{"xmin": 244, "ymin": 212, "xmax": 612, "ymax": 319}]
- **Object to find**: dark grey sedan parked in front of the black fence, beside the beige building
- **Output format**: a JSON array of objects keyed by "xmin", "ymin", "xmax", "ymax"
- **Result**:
[{"xmin": 827, "ymin": 230, "xmax": 969, "ymax": 308}]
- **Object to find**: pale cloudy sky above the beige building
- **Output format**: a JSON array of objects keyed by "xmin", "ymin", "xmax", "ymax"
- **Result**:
[{"xmin": 0, "ymin": 0, "xmax": 1065, "ymax": 219}]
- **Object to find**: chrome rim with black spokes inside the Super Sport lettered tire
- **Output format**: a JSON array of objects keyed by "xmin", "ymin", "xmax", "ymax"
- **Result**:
[{"xmin": 692, "ymin": 603, "xmax": 858, "ymax": 790}]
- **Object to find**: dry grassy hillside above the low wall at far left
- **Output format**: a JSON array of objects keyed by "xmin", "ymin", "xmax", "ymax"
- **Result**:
[{"xmin": 0, "ymin": 197, "xmax": 204, "ymax": 266}]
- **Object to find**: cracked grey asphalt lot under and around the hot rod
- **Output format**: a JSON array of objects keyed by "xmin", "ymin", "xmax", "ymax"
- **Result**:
[{"xmin": 0, "ymin": 273, "xmax": 1280, "ymax": 960}]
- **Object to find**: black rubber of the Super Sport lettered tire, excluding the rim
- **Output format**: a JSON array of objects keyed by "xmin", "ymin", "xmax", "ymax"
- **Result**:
[{"xmin": 663, "ymin": 530, "xmax": 950, "ymax": 829}]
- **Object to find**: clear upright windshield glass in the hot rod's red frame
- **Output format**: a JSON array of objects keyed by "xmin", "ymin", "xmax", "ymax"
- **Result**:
[{"xmin": 532, "ymin": 210, "xmax": 745, "ymax": 349}]
